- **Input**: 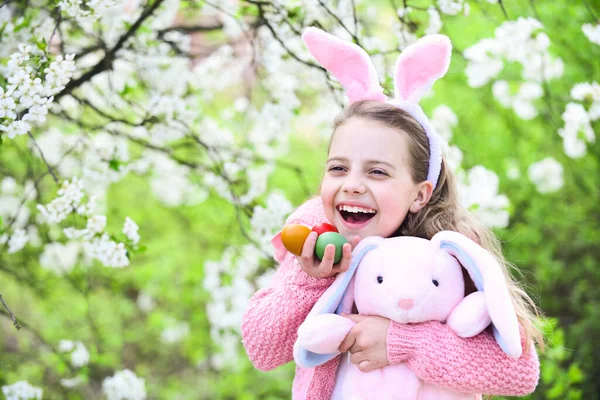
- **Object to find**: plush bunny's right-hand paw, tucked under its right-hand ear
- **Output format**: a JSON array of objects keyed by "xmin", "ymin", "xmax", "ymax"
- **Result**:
[{"xmin": 446, "ymin": 292, "xmax": 492, "ymax": 337}]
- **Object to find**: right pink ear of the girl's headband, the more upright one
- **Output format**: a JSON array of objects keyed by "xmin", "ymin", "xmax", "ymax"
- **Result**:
[{"xmin": 394, "ymin": 35, "xmax": 452, "ymax": 103}]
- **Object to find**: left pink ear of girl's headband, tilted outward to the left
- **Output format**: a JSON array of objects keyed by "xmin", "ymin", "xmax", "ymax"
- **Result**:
[{"xmin": 302, "ymin": 27, "xmax": 386, "ymax": 103}]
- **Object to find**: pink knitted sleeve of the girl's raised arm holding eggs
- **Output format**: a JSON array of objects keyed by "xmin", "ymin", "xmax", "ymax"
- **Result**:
[{"xmin": 242, "ymin": 198, "xmax": 335, "ymax": 371}]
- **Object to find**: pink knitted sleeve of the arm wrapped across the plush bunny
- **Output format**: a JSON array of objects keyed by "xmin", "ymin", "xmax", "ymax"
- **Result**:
[{"xmin": 387, "ymin": 321, "xmax": 540, "ymax": 396}]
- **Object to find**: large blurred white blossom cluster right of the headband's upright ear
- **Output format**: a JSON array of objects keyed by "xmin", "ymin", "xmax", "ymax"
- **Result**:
[{"xmin": 464, "ymin": 18, "xmax": 564, "ymax": 95}]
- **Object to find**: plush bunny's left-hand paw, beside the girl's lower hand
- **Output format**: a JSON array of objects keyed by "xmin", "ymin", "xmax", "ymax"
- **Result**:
[{"xmin": 297, "ymin": 314, "xmax": 355, "ymax": 354}]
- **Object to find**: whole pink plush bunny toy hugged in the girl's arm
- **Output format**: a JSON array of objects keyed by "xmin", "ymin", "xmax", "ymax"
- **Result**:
[{"xmin": 294, "ymin": 231, "xmax": 522, "ymax": 400}]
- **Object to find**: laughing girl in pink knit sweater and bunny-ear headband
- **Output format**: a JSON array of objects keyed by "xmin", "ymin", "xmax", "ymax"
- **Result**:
[{"xmin": 242, "ymin": 28, "xmax": 541, "ymax": 400}]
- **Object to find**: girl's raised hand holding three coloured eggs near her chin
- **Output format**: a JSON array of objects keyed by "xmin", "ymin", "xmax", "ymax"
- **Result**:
[{"xmin": 296, "ymin": 232, "xmax": 360, "ymax": 278}]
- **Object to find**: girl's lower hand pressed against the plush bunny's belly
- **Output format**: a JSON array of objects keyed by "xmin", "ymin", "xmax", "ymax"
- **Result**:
[{"xmin": 338, "ymin": 313, "xmax": 390, "ymax": 372}]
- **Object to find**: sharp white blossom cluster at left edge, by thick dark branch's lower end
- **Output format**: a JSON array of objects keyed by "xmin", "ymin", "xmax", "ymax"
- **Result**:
[{"xmin": 0, "ymin": 44, "xmax": 75, "ymax": 139}]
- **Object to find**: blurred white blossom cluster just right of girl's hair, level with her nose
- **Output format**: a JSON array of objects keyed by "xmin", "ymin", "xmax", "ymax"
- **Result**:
[{"xmin": 457, "ymin": 165, "xmax": 509, "ymax": 228}]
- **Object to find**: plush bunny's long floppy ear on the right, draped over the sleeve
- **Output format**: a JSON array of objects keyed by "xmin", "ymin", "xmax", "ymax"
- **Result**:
[{"xmin": 431, "ymin": 231, "xmax": 523, "ymax": 358}]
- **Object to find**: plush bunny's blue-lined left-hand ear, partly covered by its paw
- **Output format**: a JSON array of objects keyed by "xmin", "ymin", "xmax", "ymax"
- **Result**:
[{"xmin": 294, "ymin": 236, "xmax": 383, "ymax": 368}]
